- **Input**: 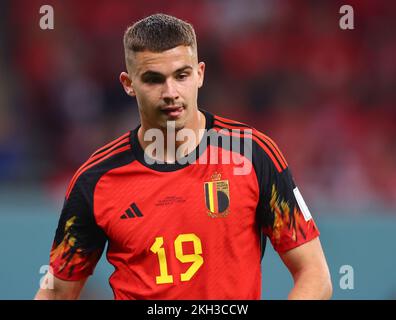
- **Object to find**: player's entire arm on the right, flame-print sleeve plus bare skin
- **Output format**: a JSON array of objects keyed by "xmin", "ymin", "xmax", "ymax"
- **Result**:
[{"xmin": 256, "ymin": 138, "xmax": 331, "ymax": 298}]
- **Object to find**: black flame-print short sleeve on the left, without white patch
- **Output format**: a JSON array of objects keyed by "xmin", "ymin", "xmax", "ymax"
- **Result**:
[{"xmin": 50, "ymin": 176, "xmax": 106, "ymax": 280}]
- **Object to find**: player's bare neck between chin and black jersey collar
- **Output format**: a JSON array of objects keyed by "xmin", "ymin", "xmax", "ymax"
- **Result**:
[{"xmin": 138, "ymin": 109, "xmax": 206, "ymax": 163}]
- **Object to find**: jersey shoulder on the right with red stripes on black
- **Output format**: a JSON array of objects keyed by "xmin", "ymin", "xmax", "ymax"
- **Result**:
[{"xmin": 213, "ymin": 115, "xmax": 288, "ymax": 172}]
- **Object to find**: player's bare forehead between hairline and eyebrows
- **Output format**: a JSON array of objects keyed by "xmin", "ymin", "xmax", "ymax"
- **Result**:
[{"xmin": 131, "ymin": 46, "xmax": 197, "ymax": 75}]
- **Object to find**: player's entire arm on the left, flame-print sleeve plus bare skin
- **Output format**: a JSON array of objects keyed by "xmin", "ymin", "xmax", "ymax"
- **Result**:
[{"xmin": 35, "ymin": 170, "xmax": 106, "ymax": 300}]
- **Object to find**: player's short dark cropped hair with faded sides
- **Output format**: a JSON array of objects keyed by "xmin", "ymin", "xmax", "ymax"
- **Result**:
[{"xmin": 124, "ymin": 13, "xmax": 197, "ymax": 56}]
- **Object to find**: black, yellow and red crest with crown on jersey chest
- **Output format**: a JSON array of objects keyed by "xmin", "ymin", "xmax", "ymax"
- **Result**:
[{"xmin": 204, "ymin": 172, "xmax": 230, "ymax": 218}]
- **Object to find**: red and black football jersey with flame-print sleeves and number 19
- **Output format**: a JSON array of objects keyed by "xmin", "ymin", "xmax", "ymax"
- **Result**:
[{"xmin": 50, "ymin": 111, "xmax": 319, "ymax": 299}]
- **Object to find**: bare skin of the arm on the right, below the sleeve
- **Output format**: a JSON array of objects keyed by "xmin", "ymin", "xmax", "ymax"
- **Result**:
[{"xmin": 279, "ymin": 238, "xmax": 333, "ymax": 300}]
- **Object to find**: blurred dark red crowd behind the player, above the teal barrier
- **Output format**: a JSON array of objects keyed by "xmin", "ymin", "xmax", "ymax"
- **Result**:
[{"xmin": 0, "ymin": 0, "xmax": 396, "ymax": 211}]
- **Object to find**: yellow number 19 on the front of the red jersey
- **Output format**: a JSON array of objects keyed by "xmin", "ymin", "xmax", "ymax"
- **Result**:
[{"xmin": 150, "ymin": 233, "xmax": 203, "ymax": 284}]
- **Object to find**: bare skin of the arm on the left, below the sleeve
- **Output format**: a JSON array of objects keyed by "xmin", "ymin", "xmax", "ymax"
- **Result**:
[{"xmin": 34, "ymin": 273, "xmax": 87, "ymax": 300}]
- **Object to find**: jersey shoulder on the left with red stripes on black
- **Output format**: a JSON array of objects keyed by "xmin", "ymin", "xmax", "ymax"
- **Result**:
[{"xmin": 66, "ymin": 131, "xmax": 133, "ymax": 198}]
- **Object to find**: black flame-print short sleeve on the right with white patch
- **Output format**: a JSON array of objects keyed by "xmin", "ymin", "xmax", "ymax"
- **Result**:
[{"xmin": 257, "ymin": 149, "xmax": 319, "ymax": 253}]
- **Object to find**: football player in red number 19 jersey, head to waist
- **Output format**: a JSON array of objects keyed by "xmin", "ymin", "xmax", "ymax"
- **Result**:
[{"xmin": 36, "ymin": 14, "xmax": 332, "ymax": 299}]
